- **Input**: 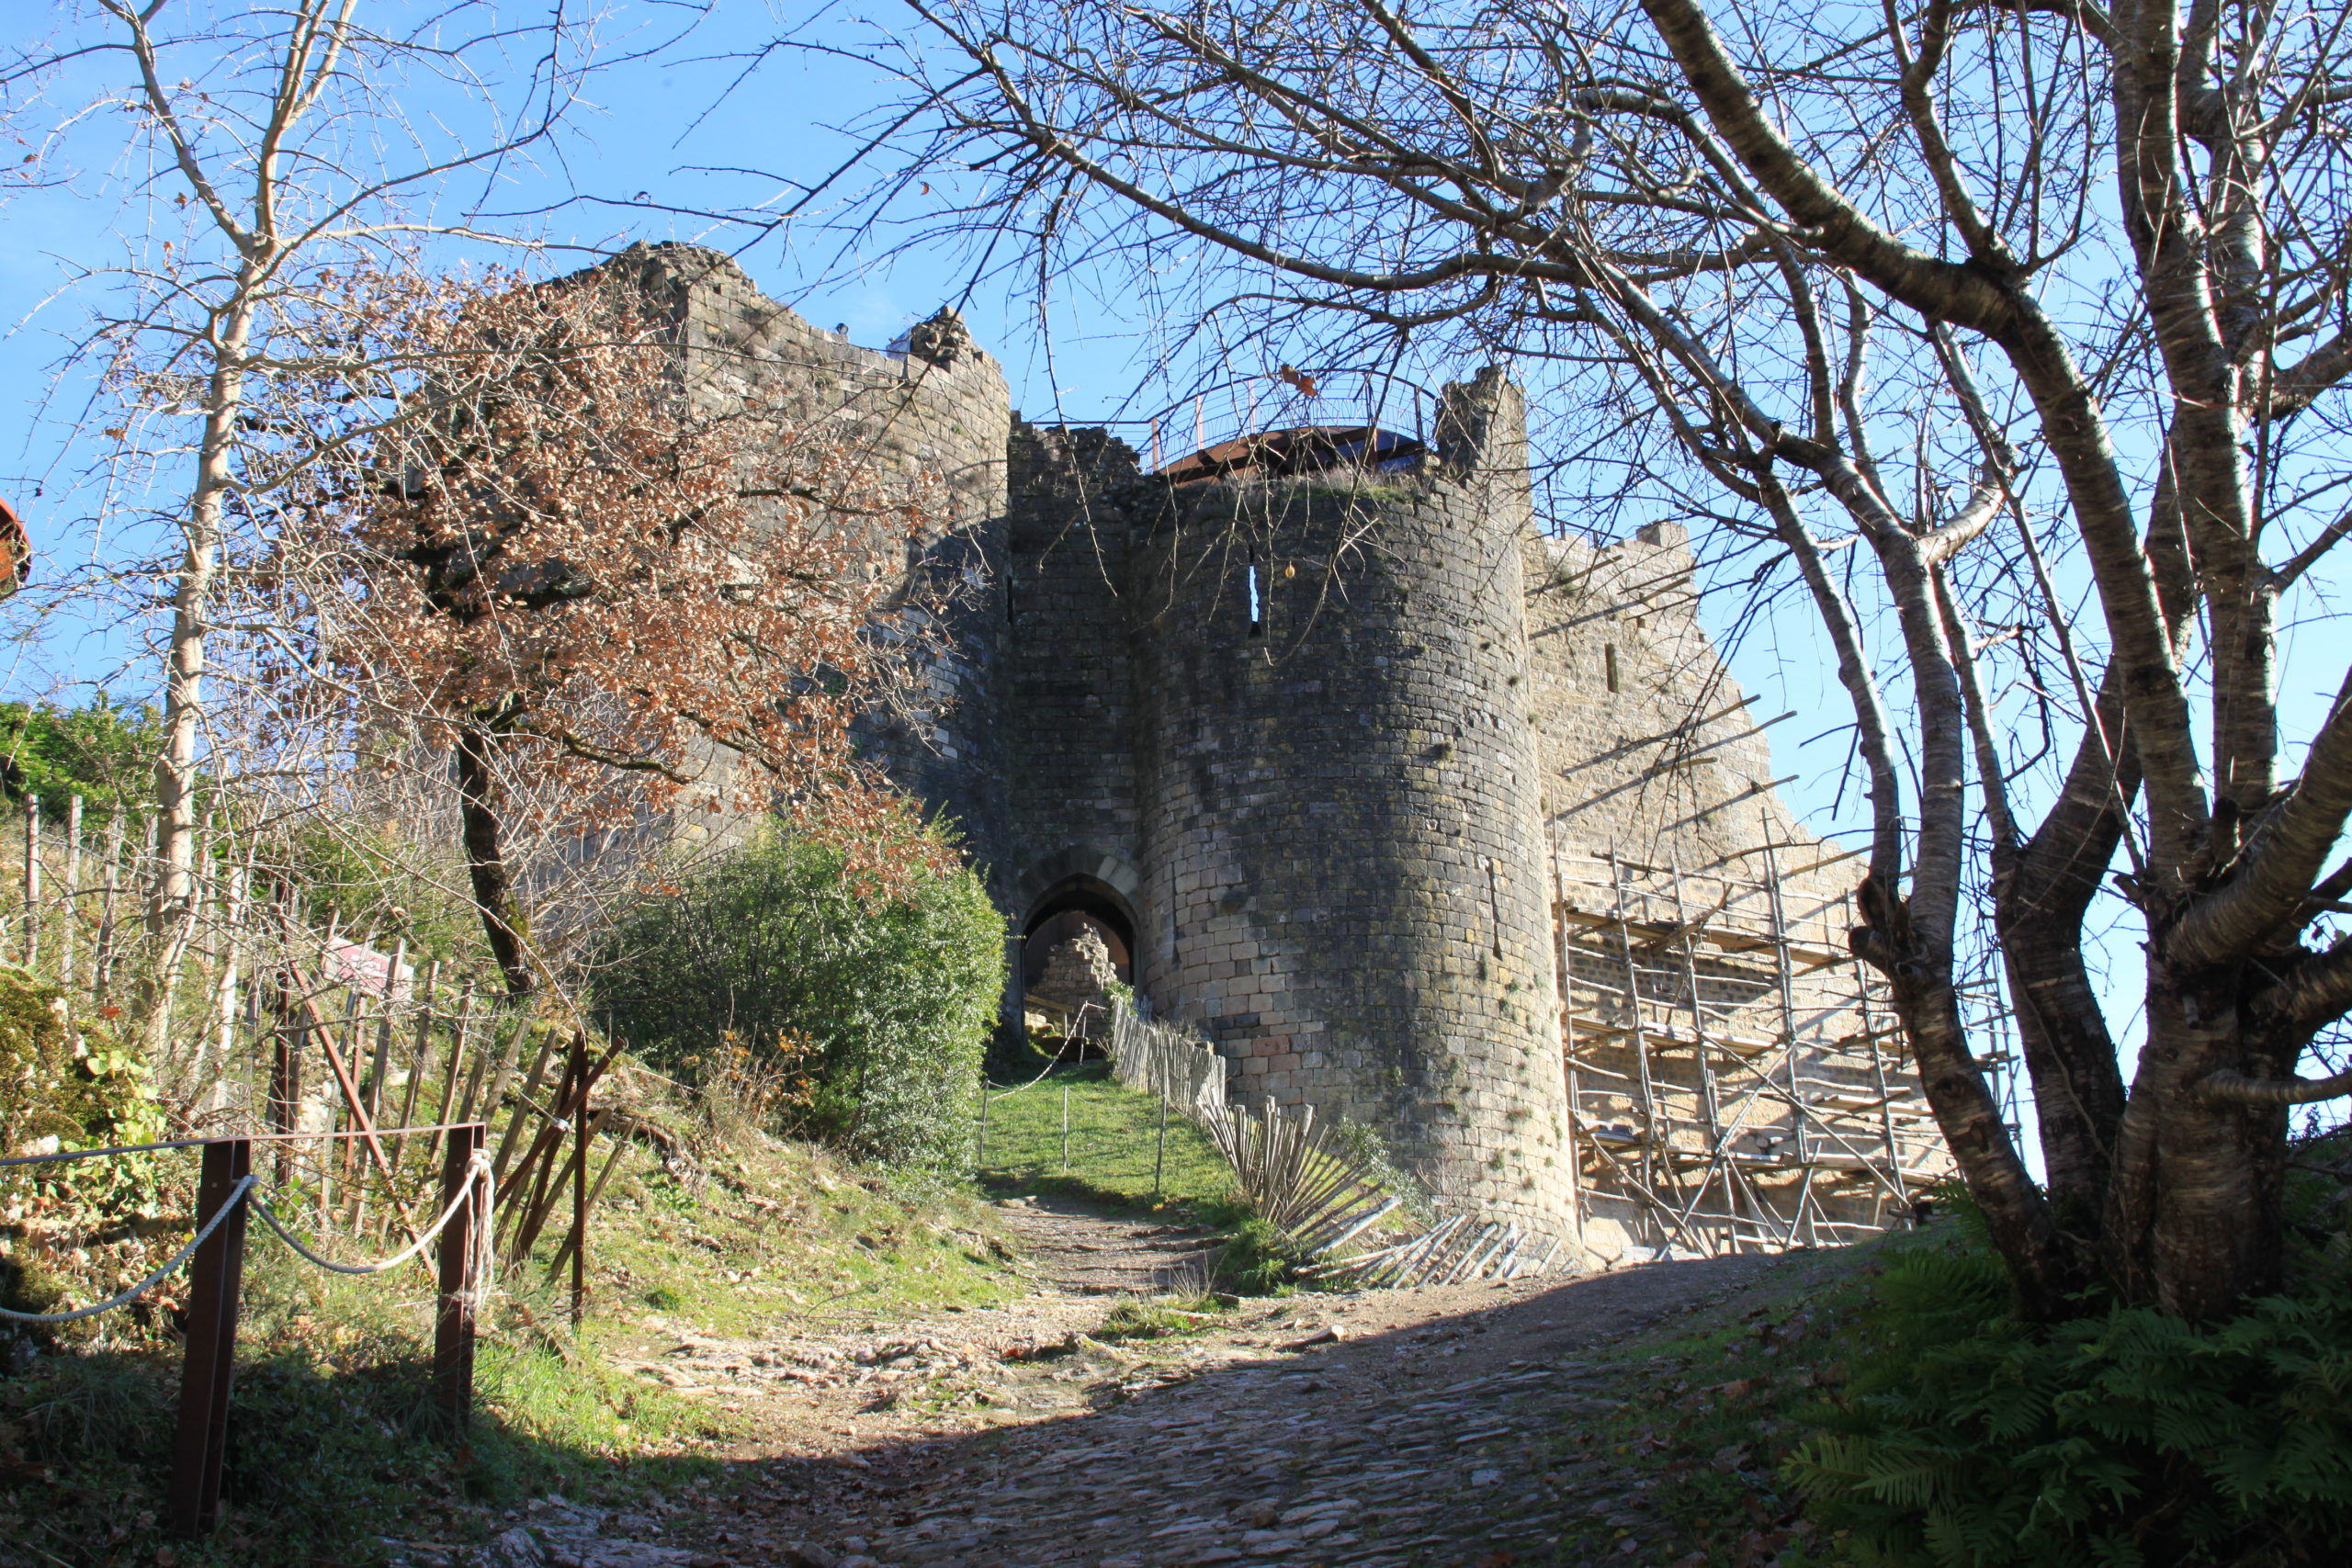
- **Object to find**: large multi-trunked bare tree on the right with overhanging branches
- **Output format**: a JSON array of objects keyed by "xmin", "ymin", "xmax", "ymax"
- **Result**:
[{"xmin": 811, "ymin": 0, "xmax": 2352, "ymax": 1316}]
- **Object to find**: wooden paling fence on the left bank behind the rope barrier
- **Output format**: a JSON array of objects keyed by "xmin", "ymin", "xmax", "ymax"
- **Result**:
[{"xmin": 0, "ymin": 797, "xmax": 642, "ymax": 1321}]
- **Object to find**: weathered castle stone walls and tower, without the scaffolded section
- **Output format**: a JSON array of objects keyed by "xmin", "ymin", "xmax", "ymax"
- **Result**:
[{"xmin": 578, "ymin": 244, "xmax": 1938, "ymax": 1239}]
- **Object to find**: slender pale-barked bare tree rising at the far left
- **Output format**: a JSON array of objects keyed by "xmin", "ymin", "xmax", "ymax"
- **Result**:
[{"xmin": 0, "ymin": 0, "xmax": 616, "ymax": 1048}]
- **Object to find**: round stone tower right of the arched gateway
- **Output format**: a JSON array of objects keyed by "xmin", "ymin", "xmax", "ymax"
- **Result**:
[{"xmin": 1129, "ymin": 371, "xmax": 1574, "ymax": 1236}]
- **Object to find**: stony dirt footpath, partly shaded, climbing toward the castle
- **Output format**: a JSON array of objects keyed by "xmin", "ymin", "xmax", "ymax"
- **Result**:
[{"xmin": 442, "ymin": 1211, "xmax": 1759, "ymax": 1568}]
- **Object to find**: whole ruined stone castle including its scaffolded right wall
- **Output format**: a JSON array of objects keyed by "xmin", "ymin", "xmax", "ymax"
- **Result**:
[{"xmin": 606, "ymin": 244, "xmax": 1945, "ymax": 1258}]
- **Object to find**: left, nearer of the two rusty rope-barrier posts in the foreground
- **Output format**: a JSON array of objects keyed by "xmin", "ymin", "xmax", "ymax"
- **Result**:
[{"xmin": 167, "ymin": 1138, "xmax": 254, "ymax": 1540}]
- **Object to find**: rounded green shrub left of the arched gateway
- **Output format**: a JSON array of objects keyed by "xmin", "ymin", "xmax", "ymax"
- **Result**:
[{"xmin": 602, "ymin": 825, "xmax": 1004, "ymax": 1170}]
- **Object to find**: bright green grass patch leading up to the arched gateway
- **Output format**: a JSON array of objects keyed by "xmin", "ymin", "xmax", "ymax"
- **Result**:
[{"xmin": 981, "ymin": 1063, "xmax": 1232, "ymax": 1208}]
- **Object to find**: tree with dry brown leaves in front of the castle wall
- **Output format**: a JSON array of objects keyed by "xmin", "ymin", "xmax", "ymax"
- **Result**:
[{"xmin": 277, "ymin": 270, "xmax": 932, "ymax": 997}]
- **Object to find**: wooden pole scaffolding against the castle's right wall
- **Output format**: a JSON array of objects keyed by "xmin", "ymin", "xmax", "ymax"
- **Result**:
[{"xmin": 1553, "ymin": 844, "xmax": 1984, "ymax": 1256}]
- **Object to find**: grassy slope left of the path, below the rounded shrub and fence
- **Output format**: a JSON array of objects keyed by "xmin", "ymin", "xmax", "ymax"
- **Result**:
[{"xmin": 0, "ymin": 1145, "xmax": 1013, "ymax": 1568}]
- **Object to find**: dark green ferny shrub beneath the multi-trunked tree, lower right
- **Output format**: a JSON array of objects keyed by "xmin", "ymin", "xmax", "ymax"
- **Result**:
[{"xmin": 1788, "ymin": 1208, "xmax": 2352, "ymax": 1568}]
